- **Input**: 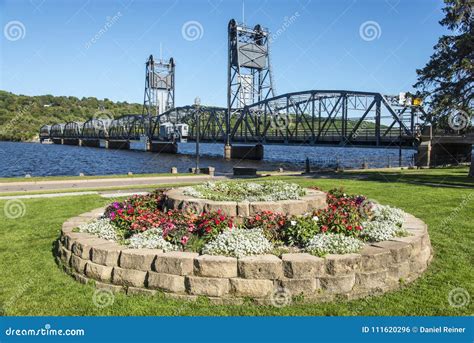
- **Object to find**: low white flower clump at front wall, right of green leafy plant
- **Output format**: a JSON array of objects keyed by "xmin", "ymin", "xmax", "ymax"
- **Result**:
[{"xmin": 305, "ymin": 233, "xmax": 364, "ymax": 256}]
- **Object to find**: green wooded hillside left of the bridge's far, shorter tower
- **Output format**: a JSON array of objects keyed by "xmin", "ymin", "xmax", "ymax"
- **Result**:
[{"xmin": 0, "ymin": 90, "xmax": 142, "ymax": 141}]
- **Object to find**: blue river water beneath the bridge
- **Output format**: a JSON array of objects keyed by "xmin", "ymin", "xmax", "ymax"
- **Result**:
[{"xmin": 0, "ymin": 142, "xmax": 414, "ymax": 177}]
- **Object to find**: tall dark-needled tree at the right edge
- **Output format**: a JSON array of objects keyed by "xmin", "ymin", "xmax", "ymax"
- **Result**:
[{"xmin": 414, "ymin": 0, "xmax": 474, "ymax": 128}]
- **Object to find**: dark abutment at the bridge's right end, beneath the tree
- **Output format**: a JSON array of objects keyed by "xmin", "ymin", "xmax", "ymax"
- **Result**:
[{"xmin": 415, "ymin": 139, "xmax": 472, "ymax": 168}]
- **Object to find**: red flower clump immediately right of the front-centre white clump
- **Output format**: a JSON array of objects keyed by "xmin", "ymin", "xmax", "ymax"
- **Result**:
[{"xmin": 244, "ymin": 211, "xmax": 288, "ymax": 245}]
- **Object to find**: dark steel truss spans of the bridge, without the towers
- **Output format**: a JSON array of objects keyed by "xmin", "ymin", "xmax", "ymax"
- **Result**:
[{"xmin": 41, "ymin": 90, "xmax": 423, "ymax": 146}]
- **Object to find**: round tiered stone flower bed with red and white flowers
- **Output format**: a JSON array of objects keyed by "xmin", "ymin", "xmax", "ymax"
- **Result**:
[{"xmin": 59, "ymin": 182, "xmax": 431, "ymax": 304}]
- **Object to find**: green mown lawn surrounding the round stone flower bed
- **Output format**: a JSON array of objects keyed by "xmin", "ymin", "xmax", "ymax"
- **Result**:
[{"xmin": 0, "ymin": 169, "xmax": 474, "ymax": 316}]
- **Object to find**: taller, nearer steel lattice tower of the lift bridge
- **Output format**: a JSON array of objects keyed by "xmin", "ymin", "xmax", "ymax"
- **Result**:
[{"xmin": 225, "ymin": 19, "xmax": 275, "ymax": 153}]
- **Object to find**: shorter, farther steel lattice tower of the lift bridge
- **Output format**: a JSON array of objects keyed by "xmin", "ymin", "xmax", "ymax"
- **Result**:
[{"xmin": 143, "ymin": 55, "xmax": 175, "ymax": 117}]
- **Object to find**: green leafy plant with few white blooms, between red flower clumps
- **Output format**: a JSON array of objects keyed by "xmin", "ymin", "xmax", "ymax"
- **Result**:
[{"xmin": 283, "ymin": 216, "xmax": 320, "ymax": 246}]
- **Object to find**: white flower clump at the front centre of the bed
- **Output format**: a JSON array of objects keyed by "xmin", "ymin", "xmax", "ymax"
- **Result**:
[{"xmin": 202, "ymin": 228, "xmax": 273, "ymax": 257}]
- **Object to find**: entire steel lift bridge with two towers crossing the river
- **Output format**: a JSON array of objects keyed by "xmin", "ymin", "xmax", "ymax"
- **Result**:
[{"xmin": 40, "ymin": 20, "xmax": 472, "ymax": 167}]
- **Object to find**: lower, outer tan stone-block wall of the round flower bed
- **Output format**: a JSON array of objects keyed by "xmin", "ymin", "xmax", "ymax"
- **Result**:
[{"xmin": 56, "ymin": 209, "xmax": 432, "ymax": 304}]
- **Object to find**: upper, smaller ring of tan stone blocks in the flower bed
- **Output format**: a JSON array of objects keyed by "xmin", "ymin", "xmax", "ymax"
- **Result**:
[{"xmin": 166, "ymin": 188, "xmax": 327, "ymax": 217}]
